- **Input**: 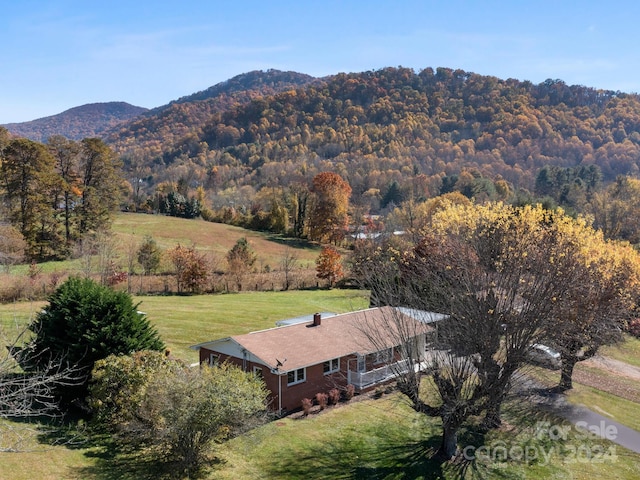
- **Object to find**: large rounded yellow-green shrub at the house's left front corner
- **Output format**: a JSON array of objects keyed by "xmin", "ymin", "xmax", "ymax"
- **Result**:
[{"xmin": 124, "ymin": 364, "xmax": 267, "ymax": 478}]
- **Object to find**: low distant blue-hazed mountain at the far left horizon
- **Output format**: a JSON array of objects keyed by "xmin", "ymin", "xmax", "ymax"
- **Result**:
[{"xmin": 2, "ymin": 102, "xmax": 148, "ymax": 142}]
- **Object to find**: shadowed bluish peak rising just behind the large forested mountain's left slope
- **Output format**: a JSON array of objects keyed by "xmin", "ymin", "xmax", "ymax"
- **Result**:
[{"xmin": 103, "ymin": 69, "xmax": 318, "ymax": 158}]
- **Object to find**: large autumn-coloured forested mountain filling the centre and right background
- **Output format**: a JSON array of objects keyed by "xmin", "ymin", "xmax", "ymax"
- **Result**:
[{"xmin": 109, "ymin": 68, "xmax": 640, "ymax": 213}]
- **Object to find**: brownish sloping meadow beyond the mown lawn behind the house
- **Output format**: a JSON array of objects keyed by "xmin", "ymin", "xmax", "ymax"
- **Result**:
[{"xmin": 0, "ymin": 212, "xmax": 322, "ymax": 302}]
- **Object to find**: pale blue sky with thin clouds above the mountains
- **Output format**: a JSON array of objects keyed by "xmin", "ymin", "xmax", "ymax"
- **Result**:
[{"xmin": 0, "ymin": 0, "xmax": 640, "ymax": 124}]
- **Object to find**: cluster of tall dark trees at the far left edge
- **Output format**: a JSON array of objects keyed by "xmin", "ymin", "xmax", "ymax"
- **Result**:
[{"xmin": 0, "ymin": 129, "xmax": 125, "ymax": 261}]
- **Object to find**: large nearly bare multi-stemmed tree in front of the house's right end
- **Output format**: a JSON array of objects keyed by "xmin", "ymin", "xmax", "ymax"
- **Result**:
[{"xmin": 354, "ymin": 202, "xmax": 596, "ymax": 458}]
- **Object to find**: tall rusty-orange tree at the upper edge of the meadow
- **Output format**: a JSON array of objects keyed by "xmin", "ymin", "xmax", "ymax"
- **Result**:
[{"xmin": 309, "ymin": 172, "xmax": 351, "ymax": 244}]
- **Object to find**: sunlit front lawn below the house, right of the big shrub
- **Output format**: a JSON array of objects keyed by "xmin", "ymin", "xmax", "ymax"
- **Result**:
[{"xmin": 209, "ymin": 394, "xmax": 640, "ymax": 480}]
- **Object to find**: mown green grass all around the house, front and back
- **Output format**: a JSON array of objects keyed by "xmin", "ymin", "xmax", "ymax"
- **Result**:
[{"xmin": 0, "ymin": 289, "xmax": 640, "ymax": 480}]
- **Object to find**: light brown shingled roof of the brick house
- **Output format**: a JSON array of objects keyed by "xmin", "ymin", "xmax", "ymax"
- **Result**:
[{"xmin": 208, "ymin": 307, "xmax": 431, "ymax": 371}]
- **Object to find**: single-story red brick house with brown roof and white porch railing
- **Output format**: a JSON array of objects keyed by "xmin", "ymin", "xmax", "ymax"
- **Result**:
[{"xmin": 191, "ymin": 307, "xmax": 434, "ymax": 412}]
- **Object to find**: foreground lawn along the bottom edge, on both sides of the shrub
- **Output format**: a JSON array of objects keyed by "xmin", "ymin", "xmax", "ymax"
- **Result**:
[{"xmin": 11, "ymin": 393, "xmax": 640, "ymax": 480}]
